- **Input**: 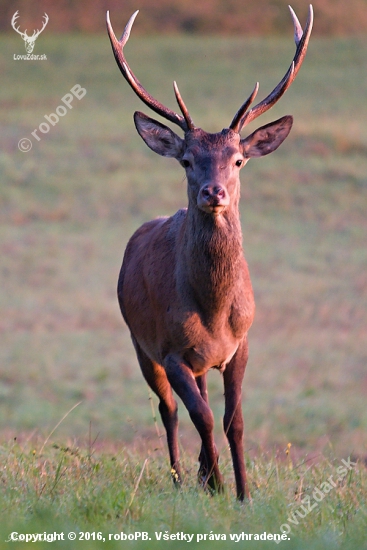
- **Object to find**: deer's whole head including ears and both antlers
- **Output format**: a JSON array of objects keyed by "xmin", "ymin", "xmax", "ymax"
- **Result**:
[{"xmin": 107, "ymin": 6, "xmax": 313, "ymax": 216}]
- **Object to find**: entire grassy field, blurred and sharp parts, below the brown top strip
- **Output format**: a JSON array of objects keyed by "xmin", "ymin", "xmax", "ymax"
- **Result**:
[{"xmin": 0, "ymin": 35, "xmax": 367, "ymax": 550}]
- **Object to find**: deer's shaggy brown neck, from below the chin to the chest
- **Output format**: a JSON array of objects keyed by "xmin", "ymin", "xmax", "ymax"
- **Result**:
[{"xmin": 181, "ymin": 205, "xmax": 243, "ymax": 314}]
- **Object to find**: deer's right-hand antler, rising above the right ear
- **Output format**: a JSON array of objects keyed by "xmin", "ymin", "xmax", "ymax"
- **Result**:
[{"xmin": 229, "ymin": 4, "xmax": 313, "ymax": 133}]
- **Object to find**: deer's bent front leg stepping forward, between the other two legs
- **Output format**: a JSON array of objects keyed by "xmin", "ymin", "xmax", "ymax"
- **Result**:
[{"xmin": 164, "ymin": 355, "xmax": 223, "ymax": 491}]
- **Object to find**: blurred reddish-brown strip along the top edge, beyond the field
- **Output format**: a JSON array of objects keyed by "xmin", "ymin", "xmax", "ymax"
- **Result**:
[{"xmin": 0, "ymin": 0, "xmax": 367, "ymax": 36}]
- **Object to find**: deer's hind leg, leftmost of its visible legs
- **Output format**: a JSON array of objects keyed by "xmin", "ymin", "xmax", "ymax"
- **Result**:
[{"xmin": 133, "ymin": 339, "xmax": 182, "ymax": 485}]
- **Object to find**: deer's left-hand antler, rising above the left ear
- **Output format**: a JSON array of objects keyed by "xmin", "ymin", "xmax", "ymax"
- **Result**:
[{"xmin": 106, "ymin": 10, "xmax": 195, "ymax": 132}]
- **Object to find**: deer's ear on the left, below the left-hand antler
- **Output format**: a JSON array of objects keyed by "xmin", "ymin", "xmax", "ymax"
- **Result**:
[{"xmin": 134, "ymin": 111, "xmax": 184, "ymax": 159}]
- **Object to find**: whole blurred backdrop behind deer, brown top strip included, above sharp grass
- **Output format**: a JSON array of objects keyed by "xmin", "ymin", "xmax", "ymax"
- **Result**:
[{"xmin": 0, "ymin": 0, "xmax": 367, "ymax": 466}]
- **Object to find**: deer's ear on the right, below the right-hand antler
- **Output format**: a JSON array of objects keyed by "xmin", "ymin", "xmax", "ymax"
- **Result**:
[{"xmin": 241, "ymin": 115, "xmax": 293, "ymax": 158}]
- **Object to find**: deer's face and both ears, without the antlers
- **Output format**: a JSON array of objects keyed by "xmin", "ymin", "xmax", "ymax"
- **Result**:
[{"xmin": 134, "ymin": 112, "xmax": 293, "ymax": 216}]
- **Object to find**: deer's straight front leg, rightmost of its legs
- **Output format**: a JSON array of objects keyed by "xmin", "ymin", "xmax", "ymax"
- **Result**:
[{"xmin": 223, "ymin": 339, "xmax": 250, "ymax": 500}]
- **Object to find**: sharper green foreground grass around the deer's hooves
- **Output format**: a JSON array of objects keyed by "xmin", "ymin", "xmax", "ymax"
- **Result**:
[{"xmin": 0, "ymin": 438, "xmax": 367, "ymax": 549}]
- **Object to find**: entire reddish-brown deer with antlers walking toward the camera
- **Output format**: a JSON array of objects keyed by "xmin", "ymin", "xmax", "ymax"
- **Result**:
[{"xmin": 107, "ymin": 5, "xmax": 313, "ymax": 501}]
